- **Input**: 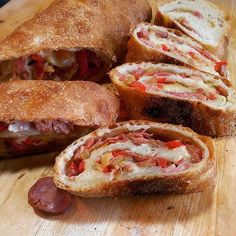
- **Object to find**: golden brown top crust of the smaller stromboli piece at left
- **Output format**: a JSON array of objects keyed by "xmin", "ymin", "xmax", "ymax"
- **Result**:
[{"xmin": 0, "ymin": 80, "xmax": 119, "ymax": 126}]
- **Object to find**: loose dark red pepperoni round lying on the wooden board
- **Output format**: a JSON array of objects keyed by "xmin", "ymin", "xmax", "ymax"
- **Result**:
[{"xmin": 28, "ymin": 177, "xmax": 72, "ymax": 214}]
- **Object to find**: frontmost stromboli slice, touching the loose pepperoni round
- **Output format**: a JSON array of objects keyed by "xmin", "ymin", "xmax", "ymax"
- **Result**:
[{"xmin": 54, "ymin": 121, "xmax": 215, "ymax": 197}]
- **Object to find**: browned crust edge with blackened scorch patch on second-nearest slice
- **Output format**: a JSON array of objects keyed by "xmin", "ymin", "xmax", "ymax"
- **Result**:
[{"xmin": 110, "ymin": 69, "xmax": 236, "ymax": 137}]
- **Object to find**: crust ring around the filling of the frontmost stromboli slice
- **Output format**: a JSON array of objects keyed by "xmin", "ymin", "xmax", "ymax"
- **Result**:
[{"xmin": 54, "ymin": 121, "xmax": 215, "ymax": 198}]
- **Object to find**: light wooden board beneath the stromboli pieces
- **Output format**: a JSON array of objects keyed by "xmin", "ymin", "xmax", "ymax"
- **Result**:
[{"xmin": 0, "ymin": 0, "xmax": 236, "ymax": 236}]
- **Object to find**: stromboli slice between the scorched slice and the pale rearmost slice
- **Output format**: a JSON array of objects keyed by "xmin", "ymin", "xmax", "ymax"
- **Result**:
[{"xmin": 126, "ymin": 23, "xmax": 229, "ymax": 78}]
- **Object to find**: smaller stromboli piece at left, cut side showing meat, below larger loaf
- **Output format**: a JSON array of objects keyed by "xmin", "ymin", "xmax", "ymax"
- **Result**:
[{"xmin": 0, "ymin": 80, "xmax": 119, "ymax": 158}]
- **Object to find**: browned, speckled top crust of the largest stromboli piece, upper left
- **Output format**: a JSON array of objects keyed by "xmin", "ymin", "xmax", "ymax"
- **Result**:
[{"xmin": 0, "ymin": 0, "xmax": 151, "ymax": 60}]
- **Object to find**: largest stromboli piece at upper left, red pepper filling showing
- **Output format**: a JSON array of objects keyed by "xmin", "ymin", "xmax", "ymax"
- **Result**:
[{"xmin": 0, "ymin": 0, "xmax": 151, "ymax": 82}]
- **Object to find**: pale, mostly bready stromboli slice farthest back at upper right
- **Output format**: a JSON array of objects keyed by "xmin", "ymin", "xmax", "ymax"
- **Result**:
[{"xmin": 155, "ymin": 0, "xmax": 230, "ymax": 58}]
